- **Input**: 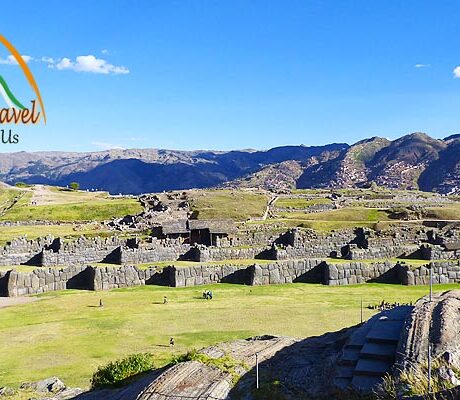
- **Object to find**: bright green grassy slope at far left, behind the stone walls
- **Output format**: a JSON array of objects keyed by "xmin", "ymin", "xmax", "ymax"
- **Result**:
[{"xmin": 0, "ymin": 198, "xmax": 142, "ymax": 221}]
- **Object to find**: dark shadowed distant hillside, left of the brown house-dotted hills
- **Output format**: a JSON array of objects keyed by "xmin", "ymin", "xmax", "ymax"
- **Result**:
[{"xmin": 0, "ymin": 144, "xmax": 348, "ymax": 194}]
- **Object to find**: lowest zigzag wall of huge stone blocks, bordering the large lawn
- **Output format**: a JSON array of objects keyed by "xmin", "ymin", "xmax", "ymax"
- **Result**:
[{"xmin": 0, "ymin": 259, "xmax": 460, "ymax": 296}]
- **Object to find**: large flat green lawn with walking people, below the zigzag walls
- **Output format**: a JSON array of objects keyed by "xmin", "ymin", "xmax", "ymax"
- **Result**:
[{"xmin": 0, "ymin": 284, "xmax": 459, "ymax": 387}]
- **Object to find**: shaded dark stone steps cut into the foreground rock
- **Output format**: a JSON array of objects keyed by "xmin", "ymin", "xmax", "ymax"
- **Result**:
[{"xmin": 334, "ymin": 306, "xmax": 413, "ymax": 392}]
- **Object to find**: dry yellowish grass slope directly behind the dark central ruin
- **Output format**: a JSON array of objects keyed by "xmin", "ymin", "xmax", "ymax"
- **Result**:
[{"xmin": 191, "ymin": 190, "xmax": 268, "ymax": 221}]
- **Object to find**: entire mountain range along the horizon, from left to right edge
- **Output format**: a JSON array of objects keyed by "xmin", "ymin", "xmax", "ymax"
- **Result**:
[{"xmin": 0, "ymin": 132, "xmax": 460, "ymax": 194}]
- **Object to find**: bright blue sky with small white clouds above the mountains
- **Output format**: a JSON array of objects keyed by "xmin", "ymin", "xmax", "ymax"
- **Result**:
[{"xmin": 0, "ymin": 0, "xmax": 460, "ymax": 151}]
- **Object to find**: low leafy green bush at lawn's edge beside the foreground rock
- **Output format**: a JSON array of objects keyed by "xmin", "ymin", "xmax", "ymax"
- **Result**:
[{"xmin": 91, "ymin": 353, "xmax": 154, "ymax": 389}]
